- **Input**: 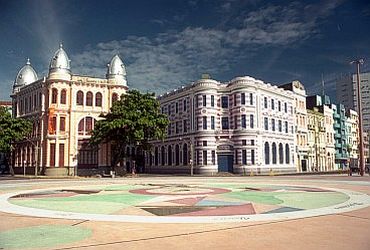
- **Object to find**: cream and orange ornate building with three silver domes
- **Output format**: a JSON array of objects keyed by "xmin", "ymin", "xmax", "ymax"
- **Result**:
[{"xmin": 11, "ymin": 45, "xmax": 128, "ymax": 175}]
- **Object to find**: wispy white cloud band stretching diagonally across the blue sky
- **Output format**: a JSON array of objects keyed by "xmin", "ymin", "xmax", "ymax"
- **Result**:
[{"xmin": 71, "ymin": 1, "xmax": 344, "ymax": 94}]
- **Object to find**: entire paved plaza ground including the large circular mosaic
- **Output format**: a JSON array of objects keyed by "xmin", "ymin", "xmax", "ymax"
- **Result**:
[{"xmin": 0, "ymin": 176, "xmax": 370, "ymax": 249}]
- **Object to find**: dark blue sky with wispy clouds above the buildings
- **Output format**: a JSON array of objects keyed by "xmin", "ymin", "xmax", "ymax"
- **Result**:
[{"xmin": 0, "ymin": 0, "xmax": 370, "ymax": 100}]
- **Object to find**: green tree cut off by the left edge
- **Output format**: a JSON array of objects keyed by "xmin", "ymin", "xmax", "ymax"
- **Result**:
[{"xmin": 0, "ymin": 107, "xmax": 32, "ymax": 175}]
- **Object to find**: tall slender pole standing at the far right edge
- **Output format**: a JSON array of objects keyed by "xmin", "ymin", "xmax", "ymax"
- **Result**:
[{"xmin": 351, "ymin": 59, "xmax": 365, "ymax": 176}]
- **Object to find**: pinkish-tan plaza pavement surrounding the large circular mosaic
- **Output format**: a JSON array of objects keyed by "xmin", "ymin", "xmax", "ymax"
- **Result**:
[{"xmin": 0, "ymin": 175, "xmax": 370, "ymax": 250}]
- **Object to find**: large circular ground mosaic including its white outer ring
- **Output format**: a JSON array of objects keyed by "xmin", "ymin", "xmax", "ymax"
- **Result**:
[{"xmin": 0, "ymin": 183, "xmax": 370, "ymax": 223}]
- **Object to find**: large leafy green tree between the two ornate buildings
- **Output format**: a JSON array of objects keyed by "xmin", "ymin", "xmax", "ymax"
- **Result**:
[{"xmin": 90, "ymin": 90, "xmax": 169, "ymax": 174}]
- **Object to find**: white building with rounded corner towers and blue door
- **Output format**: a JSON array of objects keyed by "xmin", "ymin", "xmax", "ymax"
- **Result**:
[{"xmin": 146, "ymin": 76, "xmax": 296, "ymax": 174}]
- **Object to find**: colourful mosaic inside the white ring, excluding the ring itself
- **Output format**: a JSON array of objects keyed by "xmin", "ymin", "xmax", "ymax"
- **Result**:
[{"xmin": 9, "ymin": 183, "xmax": 349, "ymax": 217}]
